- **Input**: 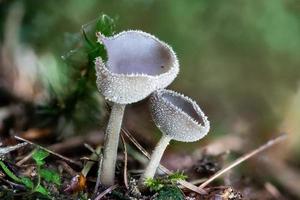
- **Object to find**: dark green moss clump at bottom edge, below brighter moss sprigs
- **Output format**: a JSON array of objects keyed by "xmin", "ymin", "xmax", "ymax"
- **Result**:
[{"xmin": 155, "ymin": 186, "xmax": 184, "ymax": 200}]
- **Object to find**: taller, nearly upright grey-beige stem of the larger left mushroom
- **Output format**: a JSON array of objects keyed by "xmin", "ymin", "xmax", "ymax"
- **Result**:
[{"xmin": 101, "ymin": 103, "xmax": 125, "ymax": 186}]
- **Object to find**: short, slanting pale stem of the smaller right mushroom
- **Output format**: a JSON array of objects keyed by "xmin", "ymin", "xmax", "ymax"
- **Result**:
[{"xmin": 140, "ymin": 135, "xmax": 171, "ymax": 185}]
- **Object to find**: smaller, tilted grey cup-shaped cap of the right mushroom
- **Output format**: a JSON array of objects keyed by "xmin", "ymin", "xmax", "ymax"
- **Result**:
[{"xmin": 150, "ymin": 89, "xmax": 210, "ymax": 142}]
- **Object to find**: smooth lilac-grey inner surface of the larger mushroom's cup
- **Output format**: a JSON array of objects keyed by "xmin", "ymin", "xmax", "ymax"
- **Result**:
[{"xmin": 103, "ymin": 35, "xmax": 174, "ymax": 76}]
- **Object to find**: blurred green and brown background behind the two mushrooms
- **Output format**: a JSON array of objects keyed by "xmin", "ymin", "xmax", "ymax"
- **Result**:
[{"xmin": 0, "ymin": 0, "xmax": 300, "ymax": 197}]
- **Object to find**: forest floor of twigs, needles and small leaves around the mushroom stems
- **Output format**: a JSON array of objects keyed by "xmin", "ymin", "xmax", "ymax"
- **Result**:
[{"xmin": 0, "ymin": 115, "xmax": 290, "ymax": 200}]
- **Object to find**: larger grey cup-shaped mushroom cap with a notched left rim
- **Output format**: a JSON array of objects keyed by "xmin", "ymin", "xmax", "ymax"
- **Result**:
[{"xmin": 95, "ymin": 30, "xmax": 179, "ymax": 104}]
